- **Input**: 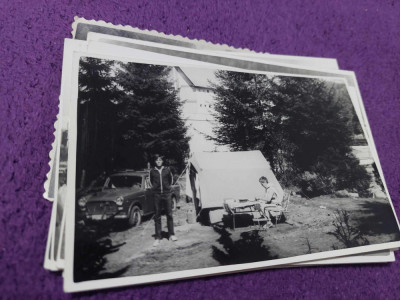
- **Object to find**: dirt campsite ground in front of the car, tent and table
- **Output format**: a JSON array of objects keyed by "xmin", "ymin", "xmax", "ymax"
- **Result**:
[{"xmin": 79, "ymin": 197, "xmax": 399, "ymax": 278}]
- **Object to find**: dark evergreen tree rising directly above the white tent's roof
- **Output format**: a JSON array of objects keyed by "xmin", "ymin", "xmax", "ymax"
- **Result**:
[{"xmin": 210, "ymin": 71, "xmax": 272, "ymax": 151}]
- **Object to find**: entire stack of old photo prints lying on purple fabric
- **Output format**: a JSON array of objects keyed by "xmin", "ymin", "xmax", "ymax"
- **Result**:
[{"xmin": 44, "ymin": 18, "xmax": 400, "ymax": 292}]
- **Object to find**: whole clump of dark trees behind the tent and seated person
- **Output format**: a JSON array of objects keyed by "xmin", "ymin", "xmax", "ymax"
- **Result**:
[{"xmin": 214, "ymin": 71, "xmax": 370, "ymax": 197}]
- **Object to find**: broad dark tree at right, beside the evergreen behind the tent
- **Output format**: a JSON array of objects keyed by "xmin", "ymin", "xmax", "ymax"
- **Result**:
[{"xmin": 272, "ymin": 77, "xmax": 353, "ymax": 171}]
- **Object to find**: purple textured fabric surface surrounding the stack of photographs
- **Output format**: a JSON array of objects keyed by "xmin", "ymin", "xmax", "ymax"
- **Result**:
[{"xmin": 0, "ymin": 0, "xmax": 400, "ymax": 299}]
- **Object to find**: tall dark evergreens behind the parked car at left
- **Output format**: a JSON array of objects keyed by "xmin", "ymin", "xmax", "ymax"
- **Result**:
[{"xmin": 77, "ymin": 58, "xmax": 188, "ymax": 187}]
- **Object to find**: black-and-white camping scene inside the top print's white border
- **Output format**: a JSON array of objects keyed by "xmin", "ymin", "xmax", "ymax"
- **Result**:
[{"xmin": 64, "ymin": 57, "xmax": 400, "ymax": 290}]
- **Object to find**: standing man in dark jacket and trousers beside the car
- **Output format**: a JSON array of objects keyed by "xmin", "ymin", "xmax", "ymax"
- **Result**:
[{"xmin": 150, "ymin": 155, "xmax": 178, "ymax": 247}]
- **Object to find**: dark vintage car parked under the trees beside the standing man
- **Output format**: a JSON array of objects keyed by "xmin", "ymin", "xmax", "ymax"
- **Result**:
[{"xmin": 78, "ymin": 170, "xmax": 180, "ymax": 227}]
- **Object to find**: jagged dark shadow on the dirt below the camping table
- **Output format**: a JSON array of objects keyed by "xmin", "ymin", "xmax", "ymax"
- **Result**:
[{"xmin": 212, "ymin": 226, "xmax": 278, "ymax": 265}]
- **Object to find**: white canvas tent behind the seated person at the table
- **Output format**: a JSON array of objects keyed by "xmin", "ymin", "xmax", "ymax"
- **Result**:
[{"xmin": 186, "ymin": 151, "xmax": 283, "ymax": 209}]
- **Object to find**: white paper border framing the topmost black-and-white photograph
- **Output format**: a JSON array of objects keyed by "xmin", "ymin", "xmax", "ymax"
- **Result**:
[{"xmin": 64, "ymin": 52, "xmax": 400, "ymax": 292}]
